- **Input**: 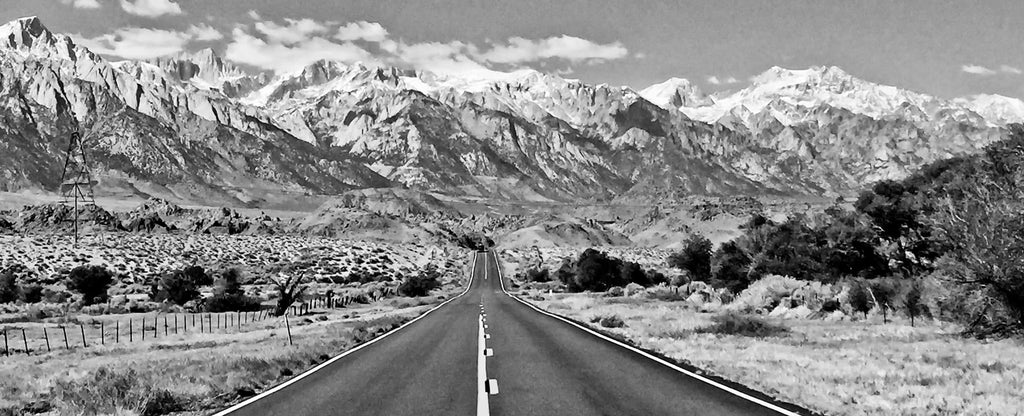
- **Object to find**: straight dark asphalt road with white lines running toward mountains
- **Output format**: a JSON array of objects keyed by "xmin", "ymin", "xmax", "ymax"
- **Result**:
[{"xmin": 218, "ymin": 252, "xmax": 798, "ymax": 416}]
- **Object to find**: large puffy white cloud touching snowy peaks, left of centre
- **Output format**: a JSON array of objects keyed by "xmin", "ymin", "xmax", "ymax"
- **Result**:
[{"xmin": 224, "ymin": 28, "xmax": 374, "ymax": 73}]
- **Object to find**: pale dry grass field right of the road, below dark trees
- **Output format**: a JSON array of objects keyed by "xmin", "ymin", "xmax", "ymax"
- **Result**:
[{"xmin": 530, "ymin": 292, "xmax": 1024, "ymax": 415}]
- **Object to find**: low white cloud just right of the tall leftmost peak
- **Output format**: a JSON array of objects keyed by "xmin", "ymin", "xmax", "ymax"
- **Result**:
[{"xmin": 72, "ymin": 28, "xmax": 194, "ymax": 59}]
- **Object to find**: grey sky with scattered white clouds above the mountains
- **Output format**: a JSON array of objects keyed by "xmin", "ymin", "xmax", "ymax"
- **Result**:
[{"xmin": 0, "ymin": 0, "xmax": 1024, "ymax": 98}]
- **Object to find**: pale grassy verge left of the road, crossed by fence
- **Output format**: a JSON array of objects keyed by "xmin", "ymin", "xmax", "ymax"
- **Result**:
[{"xmin": 0, "ymin": 295, "xmax": 459, "ymax": 415}]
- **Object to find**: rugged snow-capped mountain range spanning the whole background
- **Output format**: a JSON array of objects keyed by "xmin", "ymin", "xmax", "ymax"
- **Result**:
[{"xmin": 0, "ymin": 17, "xmax": 1024, "ymax": 205}]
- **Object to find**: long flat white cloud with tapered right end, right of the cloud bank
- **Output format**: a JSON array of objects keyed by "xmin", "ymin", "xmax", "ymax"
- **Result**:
[{"xmin": 479, "ymin": 35, "xmax": 629, "ymax": 64}]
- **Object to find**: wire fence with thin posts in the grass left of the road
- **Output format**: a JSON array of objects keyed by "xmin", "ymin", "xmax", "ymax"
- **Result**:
[{"xmin": 0, "ymin": 288, "xmax": 395, "ymax": 357}]
